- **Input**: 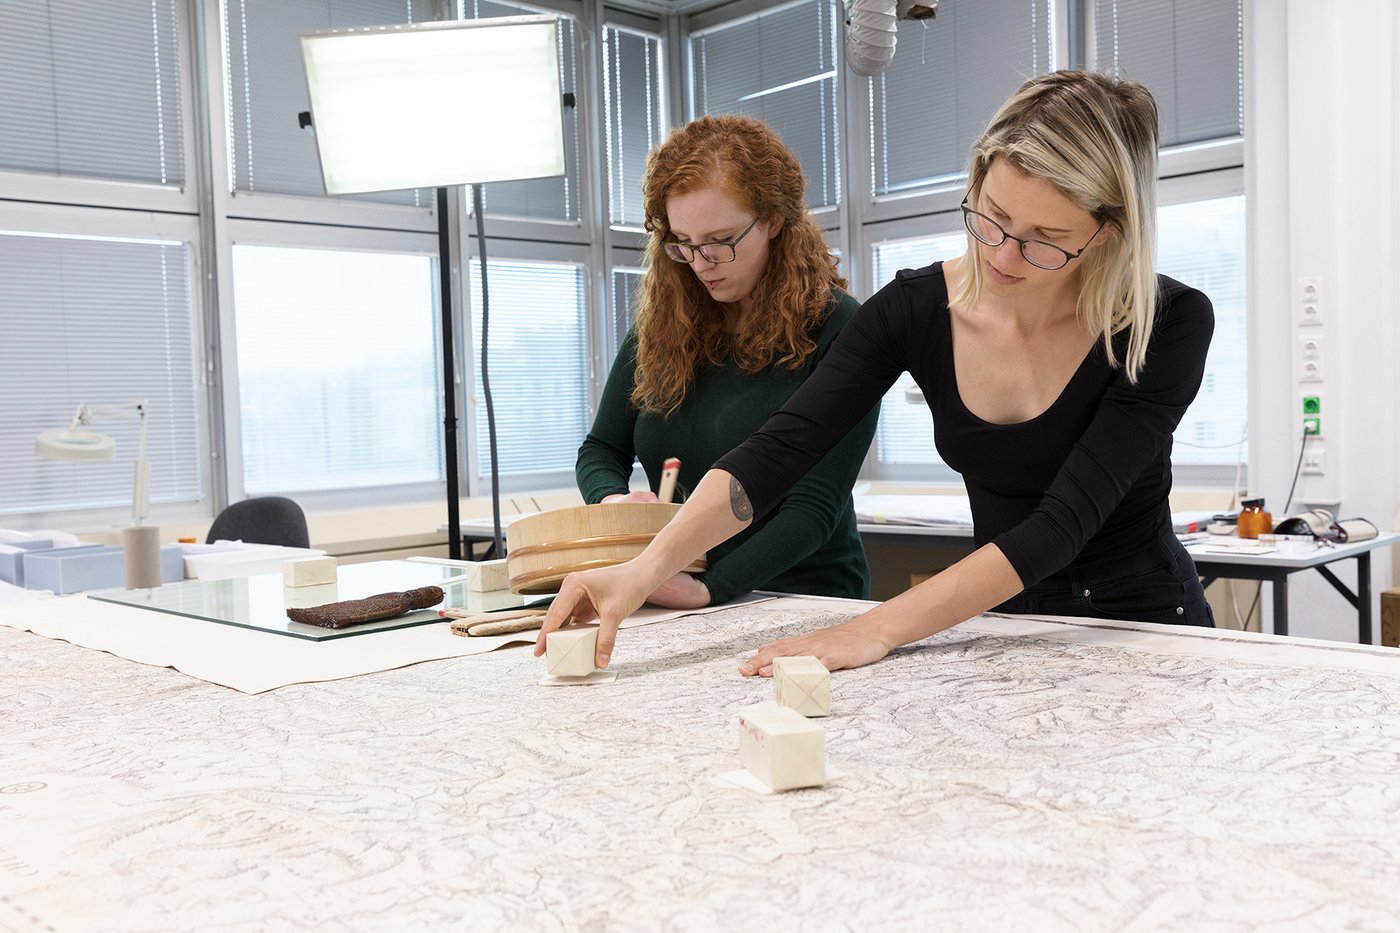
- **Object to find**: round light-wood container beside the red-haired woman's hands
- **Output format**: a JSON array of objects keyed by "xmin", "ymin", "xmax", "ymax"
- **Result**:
[{"xmin": 505, "ymin": 502, "xmax": 706, "ymax": 594}]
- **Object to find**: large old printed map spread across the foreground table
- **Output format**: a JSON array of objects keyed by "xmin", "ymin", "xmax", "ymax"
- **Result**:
[{"xmin": 0, "ymin": 600, "xmax": 1400, "ymax": 933}]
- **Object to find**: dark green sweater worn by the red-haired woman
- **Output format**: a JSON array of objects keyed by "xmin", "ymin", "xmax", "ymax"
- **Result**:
[{"xmin": 574, "ymin": 291, "xmax": 879, "ymax": 604}]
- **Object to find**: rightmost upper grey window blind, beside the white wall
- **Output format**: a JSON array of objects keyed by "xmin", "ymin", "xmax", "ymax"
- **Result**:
[{"xmin": 1093, "ymin": 0, "xmax": 1248, "ymax": 147}]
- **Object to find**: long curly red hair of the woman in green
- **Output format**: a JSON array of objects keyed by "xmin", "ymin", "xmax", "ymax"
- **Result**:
[{"xmin": 631, "ymin": 115, "xmax": 846, "ymax": 415}]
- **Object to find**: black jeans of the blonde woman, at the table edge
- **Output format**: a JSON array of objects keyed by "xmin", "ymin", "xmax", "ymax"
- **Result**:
[{"xmin": 993, "ymin": 528, "xmax": 1215, "ymax": 628}]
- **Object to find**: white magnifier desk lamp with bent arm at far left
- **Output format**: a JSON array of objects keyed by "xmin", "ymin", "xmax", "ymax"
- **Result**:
[{"xmin": 34, "ymin": 398, "xmax": 161, "ymax": 590}]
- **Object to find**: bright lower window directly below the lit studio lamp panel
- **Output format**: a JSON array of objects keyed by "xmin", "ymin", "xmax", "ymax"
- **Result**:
[{"xmin": 234, "ymin": 245, "xmax": 442, "ymax": 495}]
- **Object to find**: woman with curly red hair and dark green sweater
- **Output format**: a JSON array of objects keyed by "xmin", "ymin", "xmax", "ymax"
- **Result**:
[{"xmin": 575, "ymin": 115, "xmax": 875, "ymax": 608}]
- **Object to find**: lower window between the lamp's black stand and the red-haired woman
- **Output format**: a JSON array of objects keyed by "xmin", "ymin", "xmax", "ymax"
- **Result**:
[{"xmin": 470, "ymin": 259, "xmax": 588, "ymax": 476}]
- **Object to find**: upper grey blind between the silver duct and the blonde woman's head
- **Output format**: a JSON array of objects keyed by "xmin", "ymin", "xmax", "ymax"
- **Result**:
[{"xmin": 865, "ymin": 0, "xmax": 1056, "ymax": 196}]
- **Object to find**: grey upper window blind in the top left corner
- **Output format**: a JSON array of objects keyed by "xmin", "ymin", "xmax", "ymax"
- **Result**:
[{"xmin": 0, "ymin": 0, "xmax": 186, "ymax": 186}]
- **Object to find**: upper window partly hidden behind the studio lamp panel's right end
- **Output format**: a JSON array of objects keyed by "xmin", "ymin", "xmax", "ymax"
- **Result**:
[{"xmin": 459, "ymin": 0, "xmax": 581, "ymax": 223}]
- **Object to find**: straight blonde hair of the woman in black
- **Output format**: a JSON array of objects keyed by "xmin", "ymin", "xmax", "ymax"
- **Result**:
[{"xmin": 952, "ymin": 71, "xmax": 1158, "ymax": 382}]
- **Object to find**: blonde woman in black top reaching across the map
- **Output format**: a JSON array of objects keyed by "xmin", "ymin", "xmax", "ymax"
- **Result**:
[{"xmin": 536, "ymin": 71, "xmax": 1214, "ymax": 675}]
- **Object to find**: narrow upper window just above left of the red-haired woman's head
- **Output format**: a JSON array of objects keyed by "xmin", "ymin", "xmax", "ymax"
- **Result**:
[{"xmin": 603, "ymin": 27, "xmax": 666, "ymax": 227}]
